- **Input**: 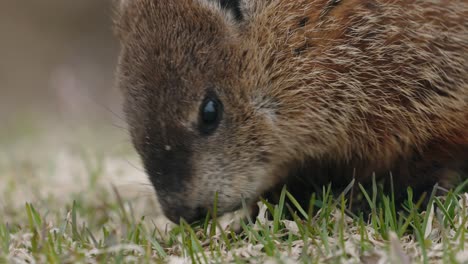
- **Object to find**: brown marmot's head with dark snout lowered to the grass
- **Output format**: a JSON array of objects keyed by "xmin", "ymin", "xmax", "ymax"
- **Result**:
[{"xmin": 116, "ymin": 0, "xmax": 286, "ymax": 221}]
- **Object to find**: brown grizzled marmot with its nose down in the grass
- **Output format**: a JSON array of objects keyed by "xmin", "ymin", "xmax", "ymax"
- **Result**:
[{"xmin": 116, "ymin": 0, "xmax": 468, "ymax": 221}]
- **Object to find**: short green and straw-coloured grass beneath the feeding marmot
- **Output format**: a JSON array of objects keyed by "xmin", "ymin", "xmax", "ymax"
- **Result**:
[{"xmin": 0, "ymin": 120, "xmax": 468, "ymax": 263}]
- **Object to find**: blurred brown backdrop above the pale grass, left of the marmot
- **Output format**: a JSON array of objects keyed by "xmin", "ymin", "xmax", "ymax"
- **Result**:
[{"xmin": 0, "ymin": 0, "xmax": 120, "ymax": 130}]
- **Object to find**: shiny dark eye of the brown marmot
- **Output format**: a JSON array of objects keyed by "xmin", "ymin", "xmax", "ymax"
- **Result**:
[{"xmin": 200, "ymin": 98, "xmax": 223, "ymax": 134}]
